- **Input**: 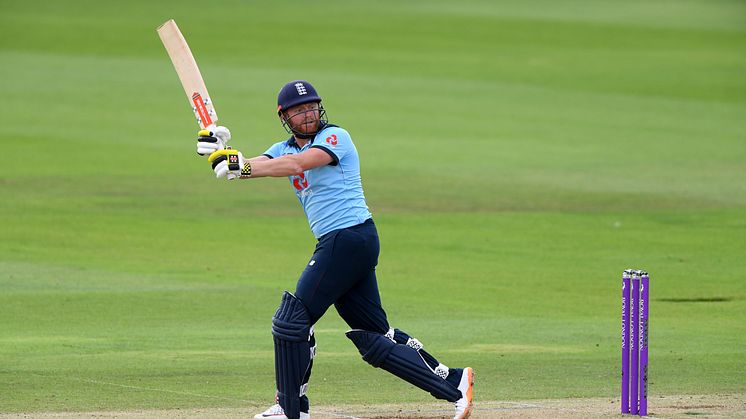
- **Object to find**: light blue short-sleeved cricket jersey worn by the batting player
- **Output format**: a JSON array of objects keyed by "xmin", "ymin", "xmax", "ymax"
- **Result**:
[{"xmin": 264, "ymin": 125, "xmax": 372, "ymax": 239}]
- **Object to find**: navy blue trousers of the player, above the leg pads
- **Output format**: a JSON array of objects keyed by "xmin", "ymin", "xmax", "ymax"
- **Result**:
[{"xmin": 295, "ymin": 219, "xmax": 389, "ymax": 334}]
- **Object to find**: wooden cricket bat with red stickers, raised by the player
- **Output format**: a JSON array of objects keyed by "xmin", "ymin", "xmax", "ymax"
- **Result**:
[{"xmin": 157, "ymin": 19, "xmax": 218, "ymax": 129}]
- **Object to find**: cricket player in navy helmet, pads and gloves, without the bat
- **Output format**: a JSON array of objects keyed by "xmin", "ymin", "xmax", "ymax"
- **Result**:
[{"xmin": 197, "ymin": 80, "xmax": 474, "ymax": 419}]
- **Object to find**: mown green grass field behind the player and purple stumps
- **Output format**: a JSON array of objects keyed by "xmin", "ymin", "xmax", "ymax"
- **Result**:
[{"xmin": 0, "ymin": 0, "xmax": 746, "ymax": 413}]
